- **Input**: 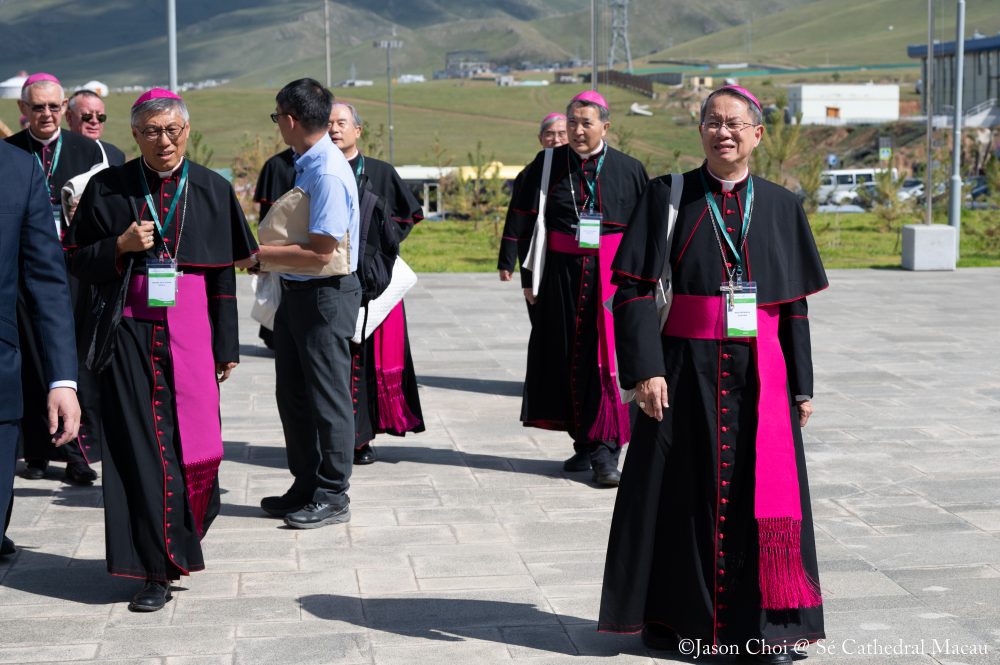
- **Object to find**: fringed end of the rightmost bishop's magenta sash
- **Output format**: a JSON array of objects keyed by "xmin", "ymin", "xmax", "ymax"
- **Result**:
[{"xmin": 757, "ymin": 517, "xmax": 823, "ymax": 610}]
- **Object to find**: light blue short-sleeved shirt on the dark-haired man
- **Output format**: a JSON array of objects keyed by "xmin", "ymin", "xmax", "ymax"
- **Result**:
[{"xmin": 282, "ymin": 133, "xmax": 361, "ymax": 280}]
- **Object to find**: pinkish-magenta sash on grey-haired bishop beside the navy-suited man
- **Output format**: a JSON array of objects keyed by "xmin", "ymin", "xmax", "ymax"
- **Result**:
[{"xmin": 124, "ymin": 274, "xmax": 222, "ymax": 534}]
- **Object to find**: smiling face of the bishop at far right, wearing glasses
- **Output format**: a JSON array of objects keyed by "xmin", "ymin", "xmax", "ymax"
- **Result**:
[{"xmin": 698, "ymin": 94, "xmax": 764, "ymax": 177}]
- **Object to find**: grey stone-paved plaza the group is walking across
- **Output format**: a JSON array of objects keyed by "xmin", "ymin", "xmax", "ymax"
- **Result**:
[{"xmin": 0, "ymin": 269, "xmax": 1000, "ymax": 665}]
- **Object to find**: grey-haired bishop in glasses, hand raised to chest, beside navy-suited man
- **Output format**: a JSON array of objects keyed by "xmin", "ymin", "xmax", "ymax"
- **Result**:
[{"xmin": 64, "ymin": 88, "xmax": 257, "ymax": 612}]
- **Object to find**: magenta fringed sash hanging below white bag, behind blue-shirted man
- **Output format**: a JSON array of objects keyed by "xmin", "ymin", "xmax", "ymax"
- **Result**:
[{"xmin": 372, "ymin": 300, "xmax": 420, "ymax": 434}]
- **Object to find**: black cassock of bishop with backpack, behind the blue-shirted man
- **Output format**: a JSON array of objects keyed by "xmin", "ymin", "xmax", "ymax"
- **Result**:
[{"xmin": 349, "ymin": 153, "xmax": 424, "ymax": 448}]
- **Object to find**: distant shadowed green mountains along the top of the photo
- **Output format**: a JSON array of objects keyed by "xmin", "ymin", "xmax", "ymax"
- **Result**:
[{"xmin": 0, "ymin": 0, "xmax": 812, "ymax": 87}]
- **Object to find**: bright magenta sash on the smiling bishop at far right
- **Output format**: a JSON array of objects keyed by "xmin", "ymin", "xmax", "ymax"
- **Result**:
[{"xmin": 663, "ymin": 294, "xmax": 822, "ymax": 610}]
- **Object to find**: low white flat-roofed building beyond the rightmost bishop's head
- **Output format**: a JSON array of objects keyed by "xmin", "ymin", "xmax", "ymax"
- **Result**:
[{"xmin": 788, "ymin": 84, "xmax": 899, "ymax": 125}]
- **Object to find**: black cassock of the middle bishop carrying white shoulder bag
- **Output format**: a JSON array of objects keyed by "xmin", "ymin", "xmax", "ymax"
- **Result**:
[{"xmin": 498, "ymin": 145, "xmax": 648, "ymax": 449}]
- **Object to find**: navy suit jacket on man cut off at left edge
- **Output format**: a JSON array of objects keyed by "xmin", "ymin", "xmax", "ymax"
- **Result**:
[{"xmin": 0, "ymin": 142, "xmax": 77, "ymax": 422}]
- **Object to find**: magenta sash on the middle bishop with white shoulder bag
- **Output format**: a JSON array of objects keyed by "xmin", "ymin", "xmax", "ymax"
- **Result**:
[{"xmin": 548, "ymin": 231, "xmax": 632, "ymax": 446}]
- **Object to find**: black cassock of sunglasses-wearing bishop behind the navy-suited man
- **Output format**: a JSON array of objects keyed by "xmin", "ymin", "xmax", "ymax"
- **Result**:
[{"xmin": 4, "ymin": 129, "xmax": 104, "ymax": 462}]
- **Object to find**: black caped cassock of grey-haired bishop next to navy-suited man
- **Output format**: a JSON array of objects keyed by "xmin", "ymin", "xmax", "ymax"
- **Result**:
[{"xmin": 65, "ymin": 159, "xmax": 257, "ymax": 580}]
